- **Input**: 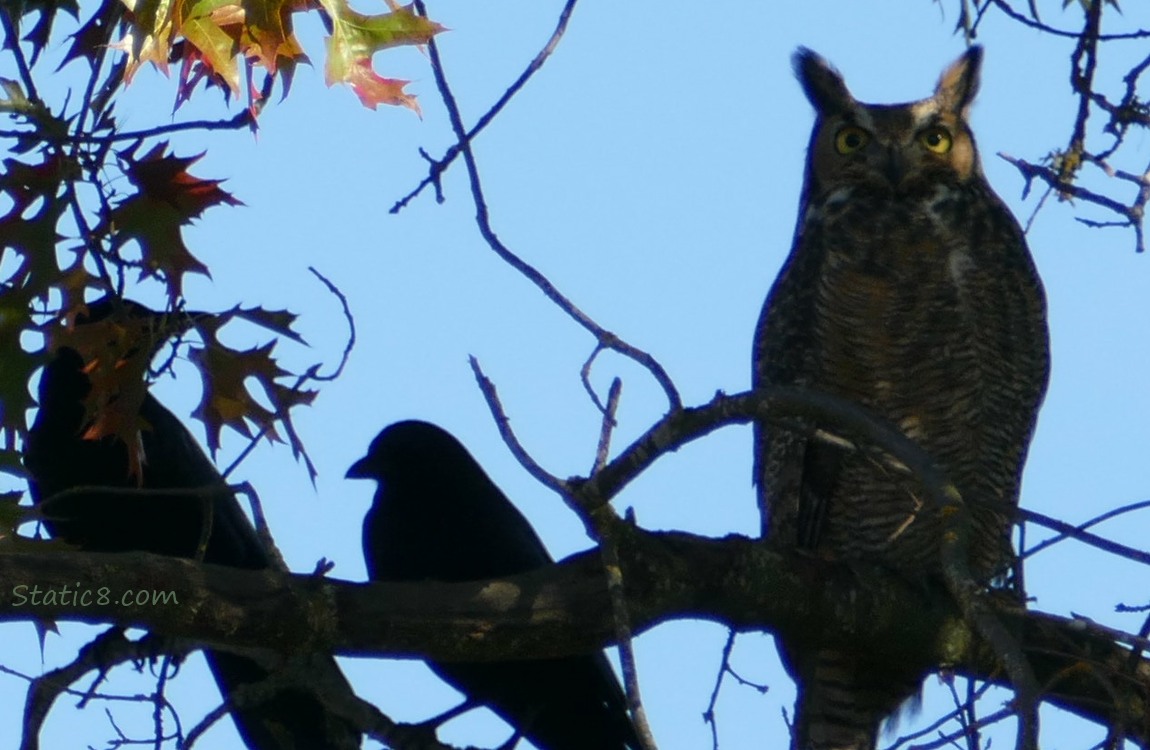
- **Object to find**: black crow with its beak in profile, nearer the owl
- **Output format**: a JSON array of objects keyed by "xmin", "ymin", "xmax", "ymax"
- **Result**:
[{"xmin": 347, "ymin": 421, "xmax": 638, "ymax": 750}]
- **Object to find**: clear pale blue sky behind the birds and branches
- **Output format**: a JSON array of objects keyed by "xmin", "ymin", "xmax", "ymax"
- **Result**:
[{"xmin": 0, "ymin": 0, "xmax": 1150, "ymax": 750}]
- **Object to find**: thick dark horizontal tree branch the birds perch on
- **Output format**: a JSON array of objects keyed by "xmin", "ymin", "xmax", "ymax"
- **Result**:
[{"xmin": 0, "ymin": 527, "xmax": 1150, "ymax": 745}]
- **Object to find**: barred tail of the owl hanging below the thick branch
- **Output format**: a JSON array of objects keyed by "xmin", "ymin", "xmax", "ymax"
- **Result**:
[{"xmin": 791, "ymin": 650, "xmax": 923, "ymax": 750}]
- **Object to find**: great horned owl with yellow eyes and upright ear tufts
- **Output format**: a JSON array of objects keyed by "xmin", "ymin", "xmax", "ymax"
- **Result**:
[{"xmin": 753, "ymin": 47, "xmax": 1049, "ymax": 750}]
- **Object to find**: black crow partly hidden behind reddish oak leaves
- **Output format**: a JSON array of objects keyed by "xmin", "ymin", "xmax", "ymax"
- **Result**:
[{"xmin": 24, "ymin": 298, "xmax": 361, "ymax": 750}]
